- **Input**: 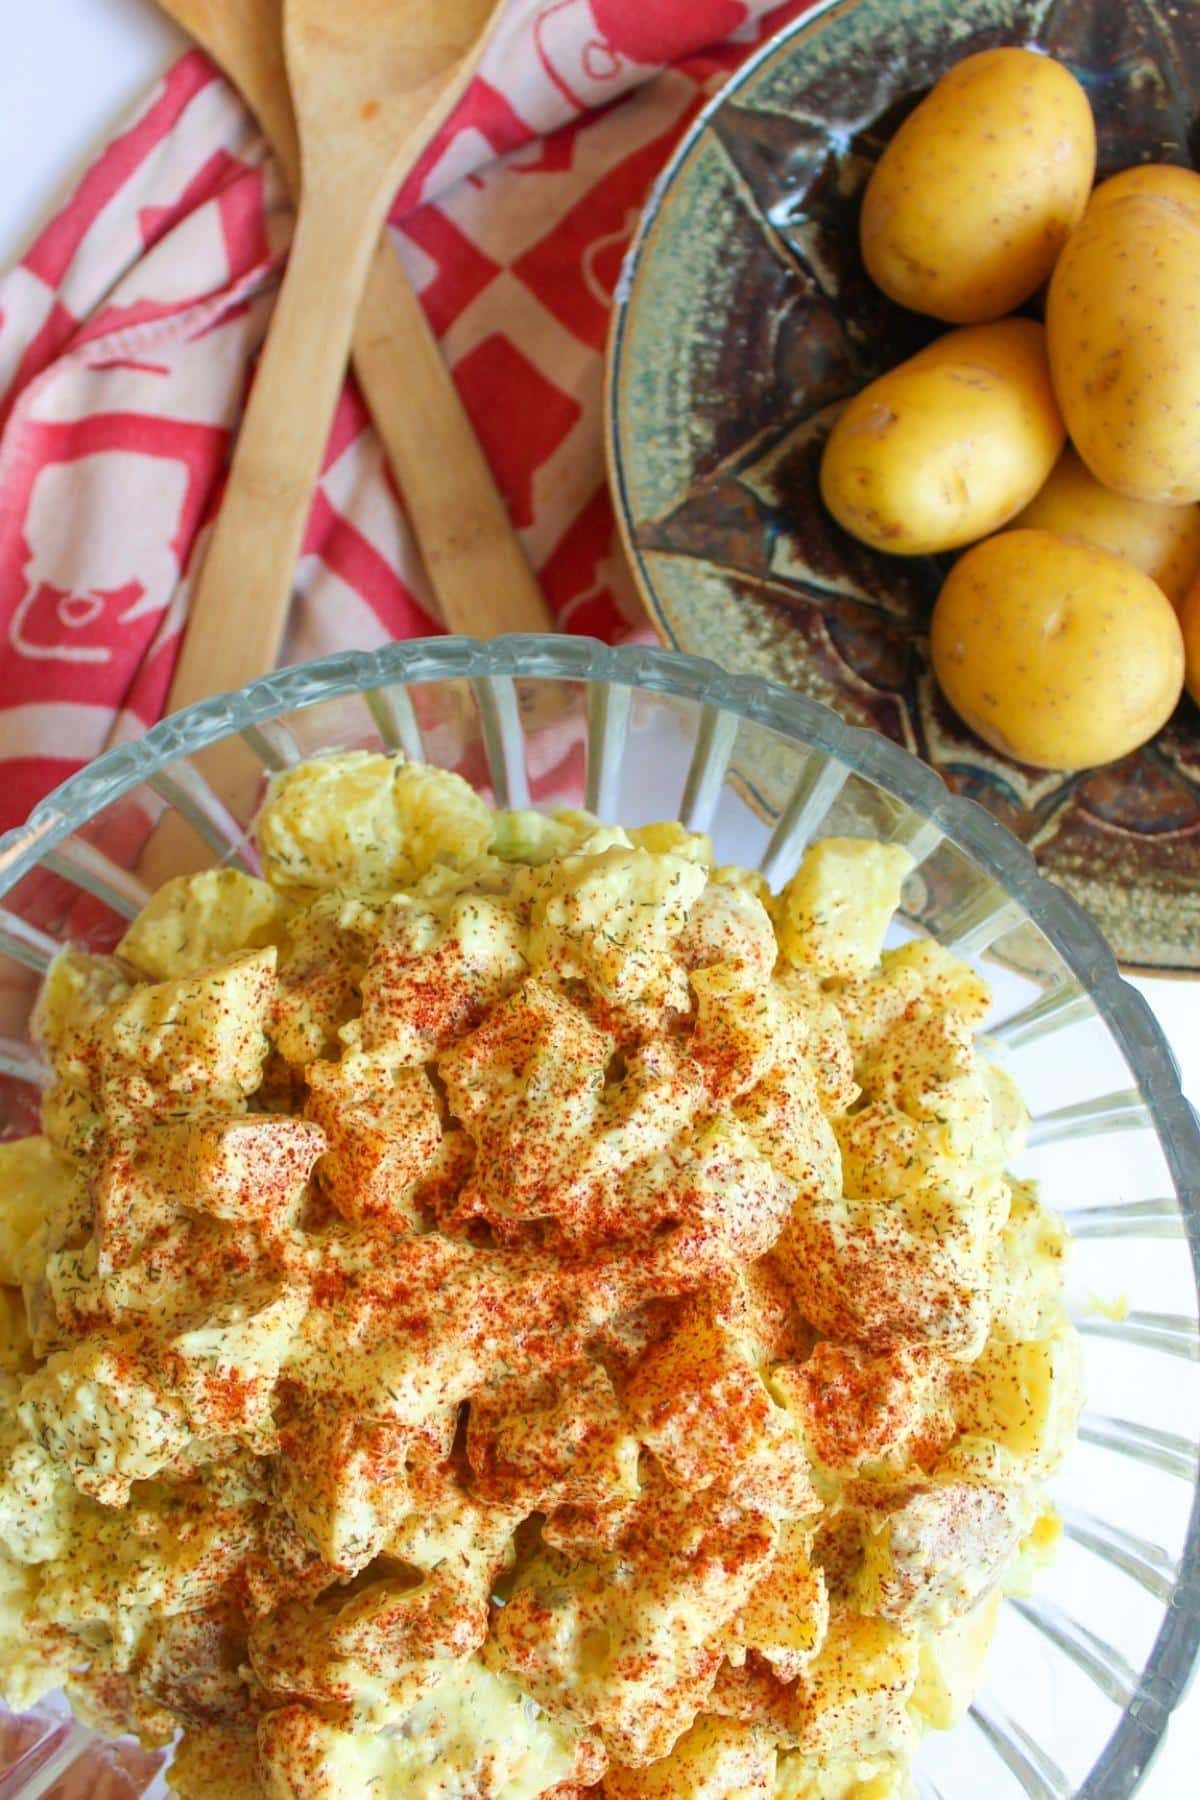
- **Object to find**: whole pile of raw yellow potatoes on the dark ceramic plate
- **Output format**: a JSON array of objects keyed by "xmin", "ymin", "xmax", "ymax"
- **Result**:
[{"xmin": 820, "ymin": 49, "xmax": 1200, "ymax": 769}]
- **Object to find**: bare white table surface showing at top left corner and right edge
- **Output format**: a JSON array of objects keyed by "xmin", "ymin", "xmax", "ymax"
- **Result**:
[{"xmin": 0, "ymin": 0, "xmax": 1200, "ymax": 1800}]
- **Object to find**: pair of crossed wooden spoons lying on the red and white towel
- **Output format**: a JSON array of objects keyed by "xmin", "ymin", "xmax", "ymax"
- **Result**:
[{"xmin": 160, "ymin": 0, "xmax": 552, "ymax": 711}]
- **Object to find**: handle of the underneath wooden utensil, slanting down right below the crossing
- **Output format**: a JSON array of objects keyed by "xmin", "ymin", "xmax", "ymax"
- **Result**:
[{"xmin": 354, "ymin": 239, "xmax": 554, "ymax": 637}]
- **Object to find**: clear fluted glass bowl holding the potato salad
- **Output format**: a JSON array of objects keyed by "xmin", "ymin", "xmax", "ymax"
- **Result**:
[{"xmin": 0, "ymin": 637, "xmax": 1200, "ymax": 1800}]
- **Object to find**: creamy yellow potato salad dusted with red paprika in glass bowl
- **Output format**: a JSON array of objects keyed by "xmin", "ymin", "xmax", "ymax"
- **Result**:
[{"xmin": 0, "ymin": 751, "xmax": 1079, "ymax": 1800}]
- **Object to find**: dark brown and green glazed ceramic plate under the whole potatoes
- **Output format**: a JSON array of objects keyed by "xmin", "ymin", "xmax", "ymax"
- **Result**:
[{"xmin": 608, "ymin": 0, "xmax": 1200, "ymax": 974}]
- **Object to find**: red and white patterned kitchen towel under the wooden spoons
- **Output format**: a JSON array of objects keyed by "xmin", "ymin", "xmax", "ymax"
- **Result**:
[{"xmin": 0, "ymin": 0, "xmax": 810, "ymax": 828}]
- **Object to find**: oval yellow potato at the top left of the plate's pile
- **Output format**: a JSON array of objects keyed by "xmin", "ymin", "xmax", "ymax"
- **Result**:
[{"xmin": 858, "ymin": 49, "xmax": 1096, "ymax": 324}]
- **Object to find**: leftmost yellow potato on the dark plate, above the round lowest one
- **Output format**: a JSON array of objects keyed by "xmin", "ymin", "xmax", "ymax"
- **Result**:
[{"xmin": 820, "ymin": 319, "xmax": 1063, "ymax": 556}]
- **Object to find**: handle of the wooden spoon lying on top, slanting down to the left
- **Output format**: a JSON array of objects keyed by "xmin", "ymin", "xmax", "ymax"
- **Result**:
[{"xmin": 167, "ymin": 184, "xmax": 389, "ymax": 713}]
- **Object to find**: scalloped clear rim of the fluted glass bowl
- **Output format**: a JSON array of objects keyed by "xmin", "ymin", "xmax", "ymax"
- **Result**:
[{"xmin": 0, "ymin": 634, "xmax": 1200, "ymax": 1800}]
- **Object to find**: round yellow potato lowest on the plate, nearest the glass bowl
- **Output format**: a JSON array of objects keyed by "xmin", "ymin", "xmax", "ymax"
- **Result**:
[{"xmin": 930, "ymin": 531, "xmax": 1184, "ymax": 769}]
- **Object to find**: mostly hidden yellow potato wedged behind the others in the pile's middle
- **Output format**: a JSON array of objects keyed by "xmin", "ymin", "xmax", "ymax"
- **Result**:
[{"xmin": 1013, "ymin": 442, "xmax": 1200, "ymax": 607}]
